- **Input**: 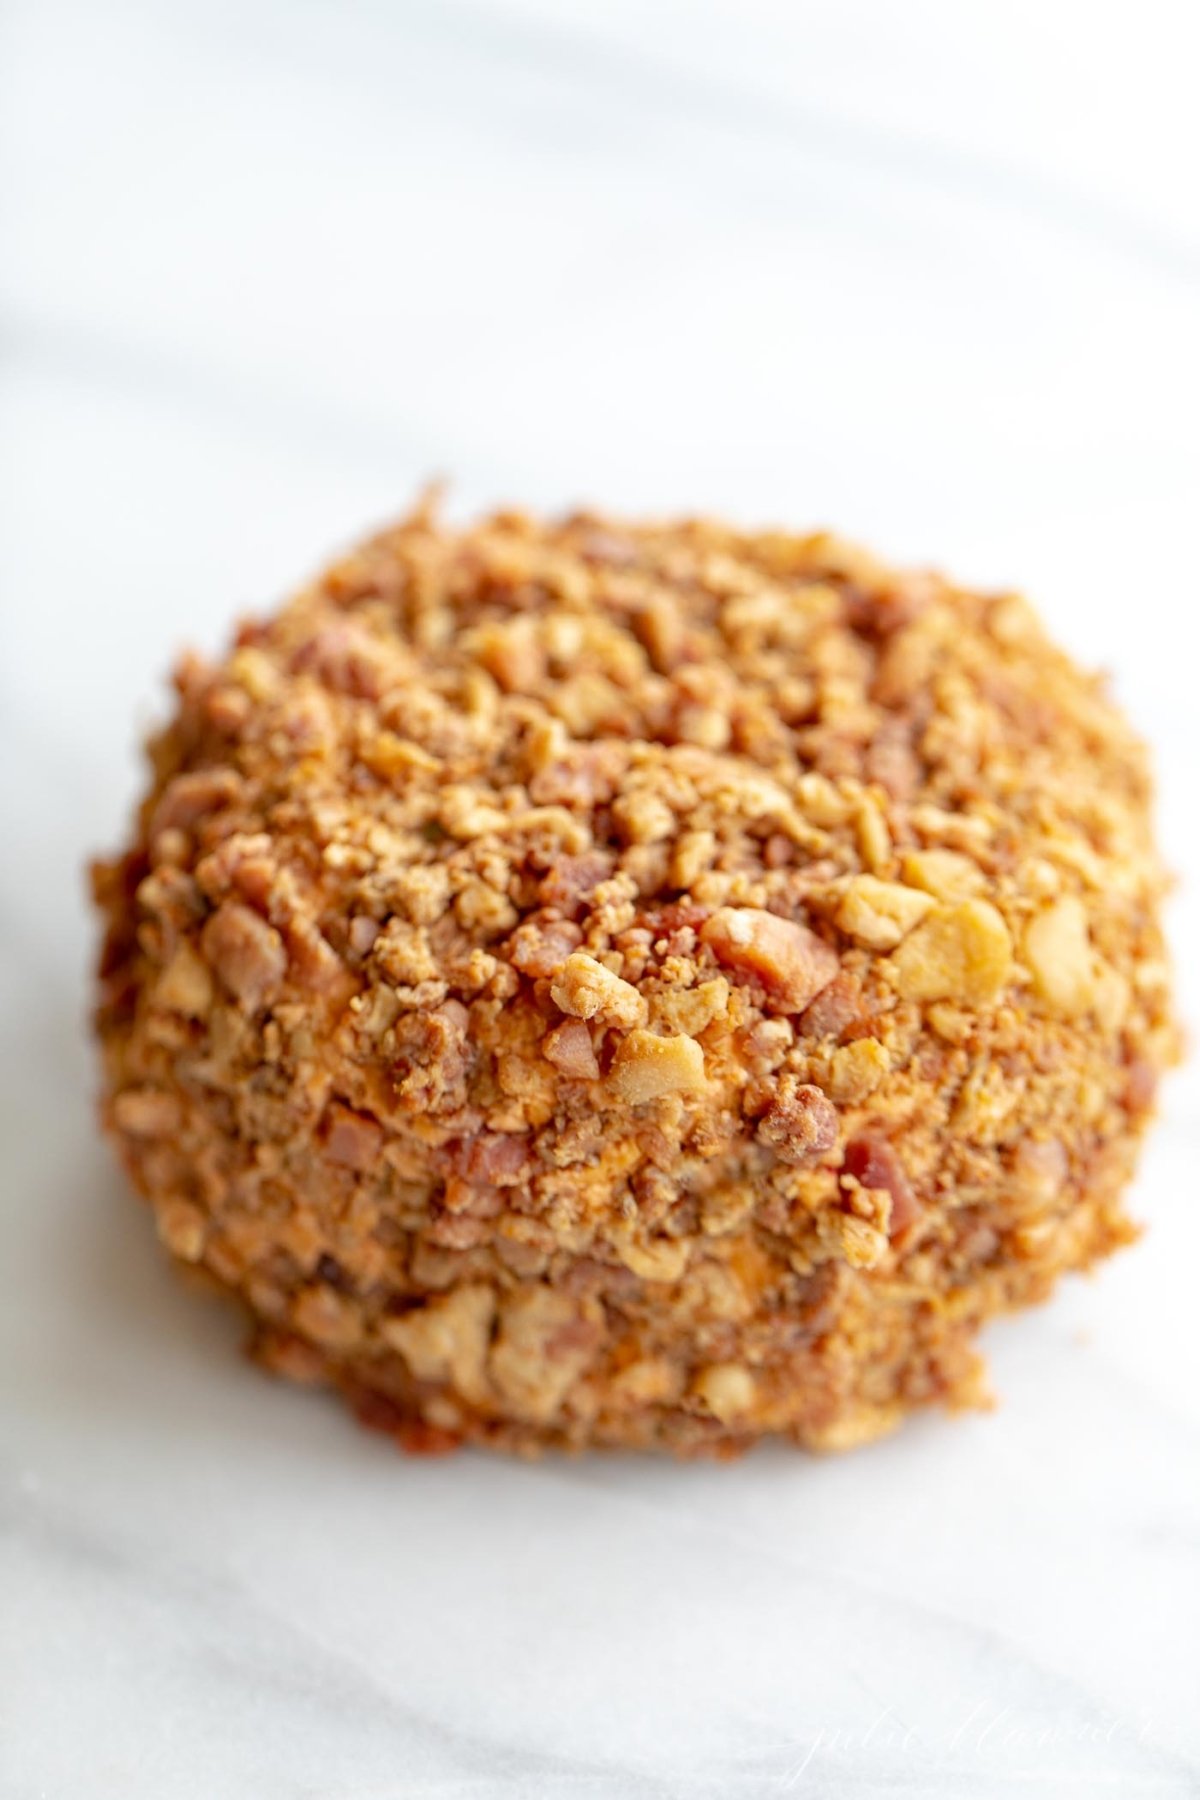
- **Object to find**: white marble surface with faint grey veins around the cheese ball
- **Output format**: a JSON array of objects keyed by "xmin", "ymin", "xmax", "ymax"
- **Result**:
[{"xmin": 0, "ymin": 0, "xmax": 1200, "ymax": 1800}]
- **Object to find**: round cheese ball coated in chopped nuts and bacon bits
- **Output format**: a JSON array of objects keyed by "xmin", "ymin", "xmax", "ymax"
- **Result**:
[{"xmin": 94, "ymin": 508, "xmax": 1175, "ymax": 1454}]
